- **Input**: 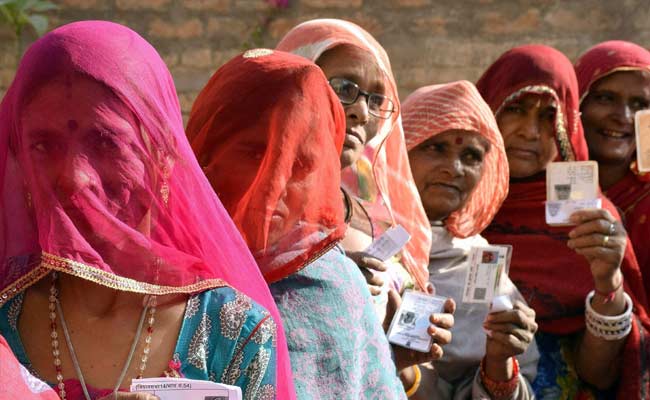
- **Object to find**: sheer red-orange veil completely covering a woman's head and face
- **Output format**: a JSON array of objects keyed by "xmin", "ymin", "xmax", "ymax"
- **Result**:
[{"xmin": 187, "ymin": 49, "xmax": 345, "ymax": 283}]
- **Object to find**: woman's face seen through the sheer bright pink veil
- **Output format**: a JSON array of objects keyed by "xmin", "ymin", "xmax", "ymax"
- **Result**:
[{"xmin": 20, "ymin": 77, "xmax": 151, "ymax": 230}]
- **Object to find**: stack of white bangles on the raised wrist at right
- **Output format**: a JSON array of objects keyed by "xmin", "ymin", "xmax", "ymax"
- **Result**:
[{"xmin": 585, "ymin": 290, "xmax": 632, "ymax": 340}]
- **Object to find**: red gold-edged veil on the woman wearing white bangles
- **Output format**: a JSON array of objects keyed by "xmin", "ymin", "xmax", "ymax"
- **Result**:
[{"xmin": 476, "ymin": 45, "xmax": 650, "ymax": 399}]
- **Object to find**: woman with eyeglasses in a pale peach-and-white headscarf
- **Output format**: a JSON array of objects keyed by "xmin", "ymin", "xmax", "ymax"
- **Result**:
[{"xmin": 277, "ymin": 19, "xmax": 455, "ymax": 394}]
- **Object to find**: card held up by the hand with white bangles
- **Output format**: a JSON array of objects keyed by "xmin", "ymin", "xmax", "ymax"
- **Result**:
[{"xmin": 545, "ymin": 161, "xmax": 601, "ymax": 226}]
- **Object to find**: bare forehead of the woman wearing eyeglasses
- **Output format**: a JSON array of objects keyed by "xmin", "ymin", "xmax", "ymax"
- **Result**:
[{"xmin": 316, "ymin": 45, "xmax": 385, "ymax": 88}]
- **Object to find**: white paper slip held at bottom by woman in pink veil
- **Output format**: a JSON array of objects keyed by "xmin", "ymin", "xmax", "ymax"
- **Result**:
[{"xmin": 130, "ymin": 378, "xmax": 242, "ymax": 400}]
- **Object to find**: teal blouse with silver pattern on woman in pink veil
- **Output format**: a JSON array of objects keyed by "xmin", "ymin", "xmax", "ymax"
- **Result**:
[{"xmin": 0, "ymin": 287, "xmax": 276, "ymax": 400}]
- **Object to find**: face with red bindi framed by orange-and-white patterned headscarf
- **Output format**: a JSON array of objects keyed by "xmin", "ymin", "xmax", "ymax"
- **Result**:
[{"xmin": 409, "ymin": 130, "xmax": 490, "ymax": 221}]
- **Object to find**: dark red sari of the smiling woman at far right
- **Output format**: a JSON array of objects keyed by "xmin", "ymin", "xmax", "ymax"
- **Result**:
[{"xmin": 574, "ymin": 40, "xmax": 650, "ymax": 296}]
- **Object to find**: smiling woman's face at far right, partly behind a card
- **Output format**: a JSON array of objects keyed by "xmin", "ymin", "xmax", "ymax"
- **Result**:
[{"xmin": 580, "ymin": 71, "xmax": 650, "ymax": 165}]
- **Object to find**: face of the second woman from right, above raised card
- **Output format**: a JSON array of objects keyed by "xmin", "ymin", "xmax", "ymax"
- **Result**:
[{"xmin": 496, "ymin": 93, "xmax": 558, "ymax": 178}]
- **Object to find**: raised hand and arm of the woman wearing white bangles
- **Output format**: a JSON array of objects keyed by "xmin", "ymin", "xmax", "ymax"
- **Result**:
[{"xmin": 567, "ymin": 209, "xmax": 627, "ymax": 390}]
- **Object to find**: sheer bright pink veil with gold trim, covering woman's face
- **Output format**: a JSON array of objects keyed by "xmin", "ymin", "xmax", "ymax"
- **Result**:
[{"xmin": 0, "ymin": 21, "xmax": 293, "ymax": 398}]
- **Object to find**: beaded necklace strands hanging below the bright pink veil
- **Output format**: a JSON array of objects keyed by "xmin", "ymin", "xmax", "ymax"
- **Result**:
[{"xmin": 49, "ymin": 272, "xmax": 156, "ymax": 400}]
